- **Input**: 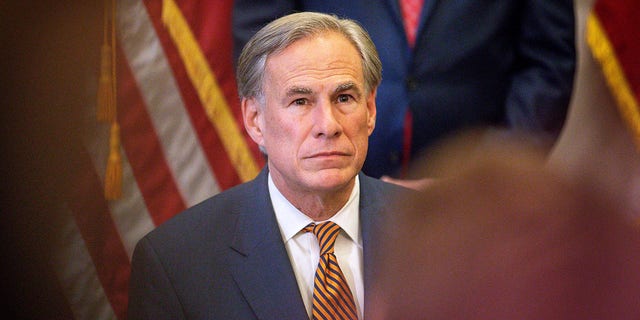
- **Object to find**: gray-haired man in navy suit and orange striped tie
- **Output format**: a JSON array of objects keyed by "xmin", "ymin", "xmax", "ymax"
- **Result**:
[{"xmin": 129, "ymin": 13, "xmax": 402, "ymax": 319}]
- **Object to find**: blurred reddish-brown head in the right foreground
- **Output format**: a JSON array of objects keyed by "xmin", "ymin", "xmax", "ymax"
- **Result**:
[{"xmin": 371, "ymin": 131, "xmax": 640, "ymax": 319}]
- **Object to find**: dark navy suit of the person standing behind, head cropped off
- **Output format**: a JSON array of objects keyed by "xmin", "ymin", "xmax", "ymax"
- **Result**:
[{"xmin": 233, "ymin": 0, "xmax": 575, "ymax": 177}]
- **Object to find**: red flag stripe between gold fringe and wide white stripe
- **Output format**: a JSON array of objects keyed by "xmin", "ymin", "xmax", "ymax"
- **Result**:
[{"xmin": 145, "ymin": 1, "xmax": 254, "ymax": 190}]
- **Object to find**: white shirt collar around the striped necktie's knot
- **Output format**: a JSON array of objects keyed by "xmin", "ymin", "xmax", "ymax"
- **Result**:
[{"xmin": 268, "ymin": 174, "xmax": 362, "ymax": 246}]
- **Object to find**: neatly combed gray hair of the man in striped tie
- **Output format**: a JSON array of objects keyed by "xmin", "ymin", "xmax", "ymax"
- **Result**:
[{"xmin": 236, "ymin": 12, "xmax": 382, "ymax": 98}]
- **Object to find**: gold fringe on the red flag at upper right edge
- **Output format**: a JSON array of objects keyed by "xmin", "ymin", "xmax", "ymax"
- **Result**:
[{"xmin": 586, "ymin": 11, "xmax": 640, "ymax": 149}]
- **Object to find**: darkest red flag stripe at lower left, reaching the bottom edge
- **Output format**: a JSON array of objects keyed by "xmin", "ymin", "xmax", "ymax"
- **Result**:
[{"xmin": 69, "ymin": 149, "xmax": 131, "ymax": 319}]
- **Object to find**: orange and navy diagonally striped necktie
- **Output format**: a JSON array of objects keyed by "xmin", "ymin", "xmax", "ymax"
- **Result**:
[{"xmin": 304, "ymin": 221, "xmax": 358, "ymax": 320}]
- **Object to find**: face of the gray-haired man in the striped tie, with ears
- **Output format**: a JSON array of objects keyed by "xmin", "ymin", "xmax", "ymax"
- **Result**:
[{"xmin": 243, "ymin": 33, "xmax": 376, "ymax": 195}]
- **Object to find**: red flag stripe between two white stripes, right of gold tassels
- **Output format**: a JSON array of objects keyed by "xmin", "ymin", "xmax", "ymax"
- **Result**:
[{"xmin": 118, "ymin": 51, "xmax": 186, "ymax": 225}]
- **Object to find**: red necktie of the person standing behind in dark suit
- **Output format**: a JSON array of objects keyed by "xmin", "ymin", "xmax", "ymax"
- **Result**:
[{"xmin": 400, "ymin": 0, "xmax": 424, "ymax": 176}]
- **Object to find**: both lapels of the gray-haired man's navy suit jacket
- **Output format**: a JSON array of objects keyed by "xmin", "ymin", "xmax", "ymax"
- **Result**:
[{"xmin": 229, "ymin": 170, "xmax": 385, "ymax": 319}]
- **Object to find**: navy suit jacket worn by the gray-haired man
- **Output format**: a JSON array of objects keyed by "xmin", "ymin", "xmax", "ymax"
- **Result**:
[{"xmin": 128, "ymin": 169, "xmax": 404, "ymax": 319}]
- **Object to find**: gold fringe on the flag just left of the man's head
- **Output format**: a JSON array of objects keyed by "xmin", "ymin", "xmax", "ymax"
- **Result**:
[{"xmin": 162, "ymin": 0, "xmax": 259, "ymax": 181}]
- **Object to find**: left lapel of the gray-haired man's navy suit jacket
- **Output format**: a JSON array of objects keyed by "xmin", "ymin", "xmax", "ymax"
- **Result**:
[{"xmin": 229, "ymin": 169, "xmax": 308, "ymax": 319}]
